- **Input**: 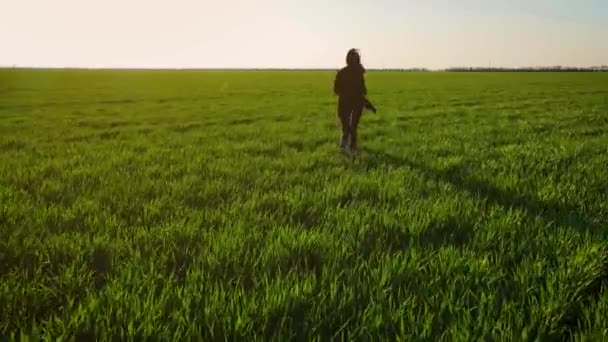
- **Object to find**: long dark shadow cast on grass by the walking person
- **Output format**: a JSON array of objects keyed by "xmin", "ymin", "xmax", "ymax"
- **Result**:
[{"xmin": 365, "ymin": 150, "xmax": 602, "ymax": 234}]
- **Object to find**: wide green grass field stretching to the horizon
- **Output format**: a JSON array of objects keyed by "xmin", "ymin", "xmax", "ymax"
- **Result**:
[{"xmin": 0, "ymin": 70, "xmax": 608, "ymax": 341}]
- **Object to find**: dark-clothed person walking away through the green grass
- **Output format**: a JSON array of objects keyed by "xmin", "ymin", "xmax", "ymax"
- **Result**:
[{"xmin": 334, "ymin": 49, "xmax": 367, "ymax": 152}]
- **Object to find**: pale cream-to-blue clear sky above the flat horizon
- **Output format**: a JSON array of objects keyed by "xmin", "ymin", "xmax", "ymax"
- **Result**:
[{"xmin": 0, "ymin": 0, "xmax": 608, "ymax": 69}]
